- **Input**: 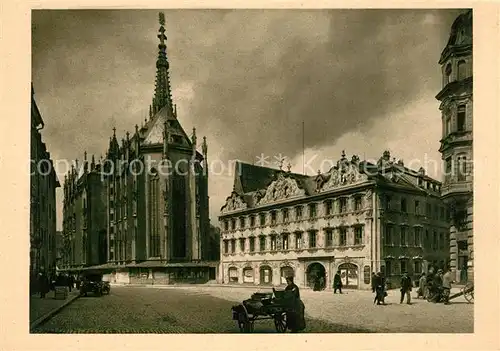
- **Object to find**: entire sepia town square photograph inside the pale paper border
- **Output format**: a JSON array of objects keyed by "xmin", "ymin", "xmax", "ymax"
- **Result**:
[{"xmin": 26, "ymin": 8, "xmax": 475, "ymax": 334}]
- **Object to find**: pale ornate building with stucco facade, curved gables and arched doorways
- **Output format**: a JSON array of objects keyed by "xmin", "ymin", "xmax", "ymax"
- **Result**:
[{"xmin": 219, "ymin": 151, "xmax": 449, "ymax": 289}]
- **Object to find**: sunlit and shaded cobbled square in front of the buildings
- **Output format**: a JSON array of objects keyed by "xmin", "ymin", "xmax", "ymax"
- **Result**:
[{"xmin": 33, "ymin": 287, "xmax": 474, "ymax": 333}]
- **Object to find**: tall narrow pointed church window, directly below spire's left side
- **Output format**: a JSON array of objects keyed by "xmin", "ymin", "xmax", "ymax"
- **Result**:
[{"xmin": 148, "ymin": 168, "xmax": 160, "ymax": 257}]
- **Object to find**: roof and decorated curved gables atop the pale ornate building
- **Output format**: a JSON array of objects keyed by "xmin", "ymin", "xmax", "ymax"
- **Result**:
[{"xmin": 221, "ymin": 151, "xmax": 440, "ymax": 213}]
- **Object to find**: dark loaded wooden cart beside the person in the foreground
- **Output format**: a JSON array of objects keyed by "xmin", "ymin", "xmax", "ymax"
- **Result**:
[{"xmin": 231, "ymin": 291, "xmax": 305, "ymax": 333}]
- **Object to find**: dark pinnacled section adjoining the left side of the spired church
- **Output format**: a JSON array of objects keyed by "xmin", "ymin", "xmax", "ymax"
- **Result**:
[{"xmin": 61, "ymin": 153, "xmax": 106, "ymax": 269}]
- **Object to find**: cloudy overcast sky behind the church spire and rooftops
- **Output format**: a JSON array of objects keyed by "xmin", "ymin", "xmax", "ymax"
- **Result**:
[{"xmin": 32, "ymin": 9, "xmax": 459, "ymax": 229}]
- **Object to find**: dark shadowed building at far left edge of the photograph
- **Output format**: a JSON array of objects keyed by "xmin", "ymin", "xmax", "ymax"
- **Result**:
[{"xmin": 30, "ymin": 86, "xmax": 60, "ymax": 274}]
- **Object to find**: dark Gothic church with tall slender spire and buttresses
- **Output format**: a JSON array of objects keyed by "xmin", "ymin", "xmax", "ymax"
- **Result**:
[{"xmin": 60, "ymin": 14, "xmax": 218, "ymax": 284}]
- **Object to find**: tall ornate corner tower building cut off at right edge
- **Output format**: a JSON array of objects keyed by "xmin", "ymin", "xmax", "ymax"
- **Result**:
[{"xmin": 436, "ymin": 10, "xmax": 474, "ymax": 282}]
